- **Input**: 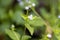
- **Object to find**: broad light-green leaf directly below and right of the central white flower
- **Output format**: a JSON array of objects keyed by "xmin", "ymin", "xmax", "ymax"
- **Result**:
[{"xmin": 28, "ymin": 17, "xmax": 44, "ymax": 26}]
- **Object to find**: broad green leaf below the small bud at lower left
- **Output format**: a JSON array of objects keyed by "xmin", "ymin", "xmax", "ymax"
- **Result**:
[{"xmin": 5, "ymin": 29, "xmax": 20, "ymax": 40}]
